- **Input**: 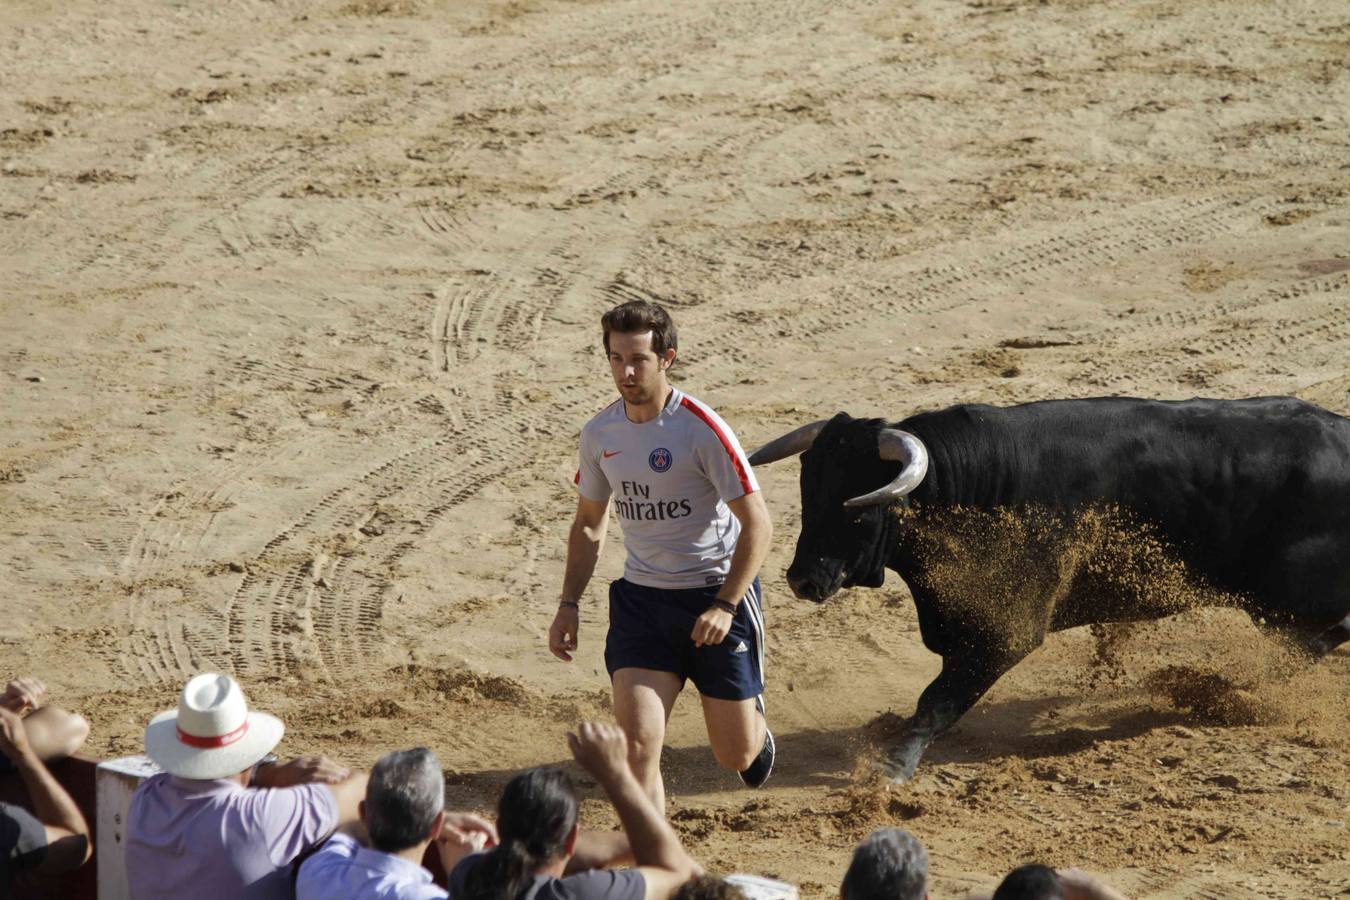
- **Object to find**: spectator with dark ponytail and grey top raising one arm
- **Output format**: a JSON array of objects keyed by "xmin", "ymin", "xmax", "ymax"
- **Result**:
[{"xmin": 450, "ymin": 722, "xmax": 698, "ymax": 900}]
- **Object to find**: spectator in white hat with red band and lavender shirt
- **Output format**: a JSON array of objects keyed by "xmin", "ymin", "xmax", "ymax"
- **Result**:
[{"xmin": 127, "ymin": 675, "xmax": 366, "ymax": 900}]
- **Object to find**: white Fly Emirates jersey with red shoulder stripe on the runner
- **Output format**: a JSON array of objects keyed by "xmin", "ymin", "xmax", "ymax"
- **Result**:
[{"xmin": 576, "ymin": 389, "xmax": 759, "ymax": 588}]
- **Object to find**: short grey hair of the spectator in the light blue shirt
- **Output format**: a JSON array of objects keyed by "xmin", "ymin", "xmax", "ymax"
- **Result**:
[{"xmin": 366, "ymin": 748, "xmax": 446, "ymax": 853}]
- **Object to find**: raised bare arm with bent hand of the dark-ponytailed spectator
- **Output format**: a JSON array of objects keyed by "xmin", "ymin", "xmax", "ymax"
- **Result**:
[{"xmin": 567, "ymin": 722, "xmax": 698, "ymax": 900}]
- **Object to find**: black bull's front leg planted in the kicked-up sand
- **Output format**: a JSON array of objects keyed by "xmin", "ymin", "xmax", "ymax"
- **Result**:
[{"xmin": 882, "ymin": 650, "xmax": 1022, "ymax": 783}]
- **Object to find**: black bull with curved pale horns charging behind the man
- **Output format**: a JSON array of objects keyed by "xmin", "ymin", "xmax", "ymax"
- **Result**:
[{"xmin": 751, "ymin": 397, "xmax": 1350, "ymax": 779}]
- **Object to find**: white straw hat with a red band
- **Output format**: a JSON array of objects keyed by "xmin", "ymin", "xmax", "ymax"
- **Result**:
[{"xmin": 146, "ymin": 673, "xmax": 286, "ymax": 779}]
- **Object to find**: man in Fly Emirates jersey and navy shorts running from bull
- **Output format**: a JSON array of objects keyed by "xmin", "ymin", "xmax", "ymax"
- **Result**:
[{"xmin": 548, "ymin": 301, "xmax": 774, "ymax": 811}]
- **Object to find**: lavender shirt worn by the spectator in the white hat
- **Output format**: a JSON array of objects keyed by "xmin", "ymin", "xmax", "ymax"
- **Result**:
[{"xmin": 127, "ymin": 775, "xmax": 338, "ymax": 900}]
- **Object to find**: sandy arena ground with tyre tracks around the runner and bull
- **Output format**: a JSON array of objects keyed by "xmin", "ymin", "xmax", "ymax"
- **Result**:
[{"xmin": 0, "ymin": 0, "xmax": 1350, "ymax": 900}]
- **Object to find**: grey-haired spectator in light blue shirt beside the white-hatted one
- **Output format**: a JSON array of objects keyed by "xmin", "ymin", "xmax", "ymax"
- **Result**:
[{"xmin": 296, "ymin": 748, "xmax": 497, "ymax": 900}]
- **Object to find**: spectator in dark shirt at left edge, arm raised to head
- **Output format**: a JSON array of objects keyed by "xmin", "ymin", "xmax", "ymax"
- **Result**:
[{"xmin": 0, "ymin": 706, "xmax": 89, "ymax": 897}]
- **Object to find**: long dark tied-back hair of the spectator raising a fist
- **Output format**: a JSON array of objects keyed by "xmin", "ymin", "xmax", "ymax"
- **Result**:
[{"xmin": 462, "ymin": 766, "xmax": 576, "ymax": 900}]
